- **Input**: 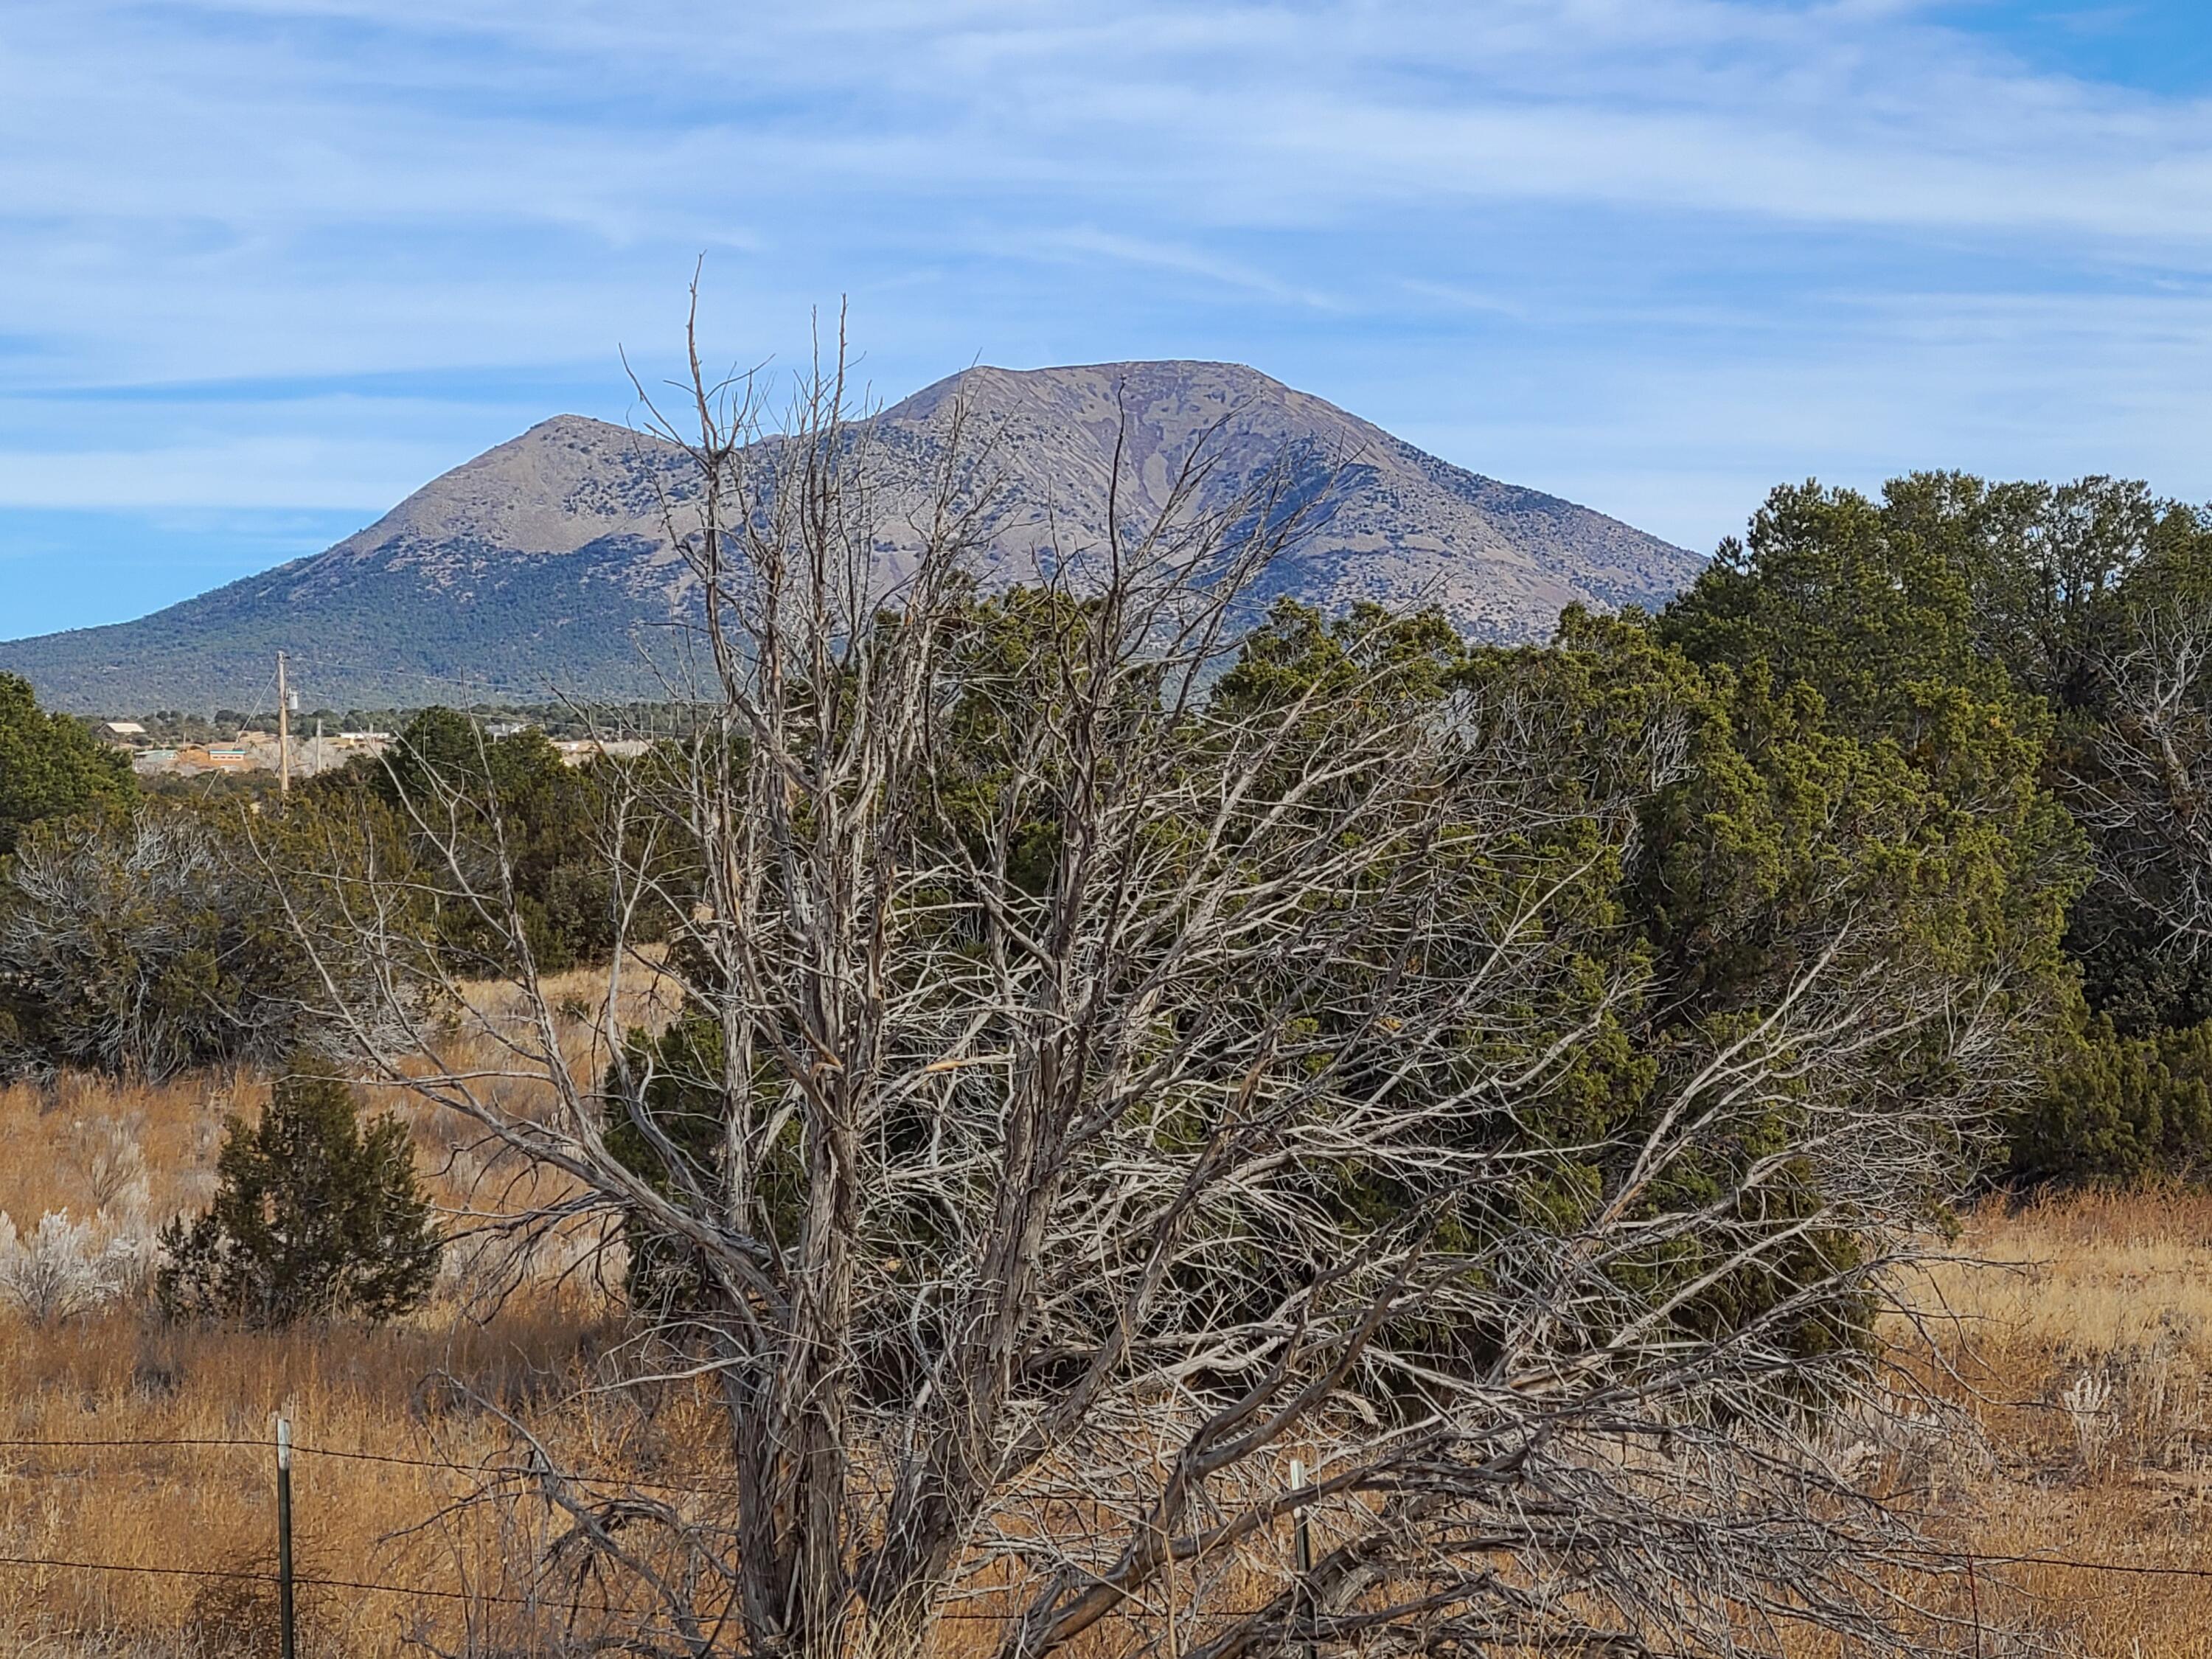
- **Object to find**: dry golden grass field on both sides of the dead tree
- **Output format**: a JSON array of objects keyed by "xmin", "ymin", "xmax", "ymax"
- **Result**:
[{"xmin": 0, "ymin": 1033, "xmax": 2212, "ymax": 1659}]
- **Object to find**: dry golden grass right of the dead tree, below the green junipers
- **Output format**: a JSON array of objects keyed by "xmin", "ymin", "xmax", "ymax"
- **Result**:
[{"xmin": 1876, "ymin": 1192, "xmax": 2212, "ymax": 1659}]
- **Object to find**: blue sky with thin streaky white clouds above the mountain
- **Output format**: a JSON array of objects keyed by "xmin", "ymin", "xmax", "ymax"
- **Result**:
[{"xmin": 0, "ymin": 0, "xmax": 2212, "ymax": 637}]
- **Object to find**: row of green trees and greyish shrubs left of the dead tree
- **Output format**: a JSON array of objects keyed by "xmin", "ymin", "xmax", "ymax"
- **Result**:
[{"xmin": 0, "ymin": 690, "xmax": 655, "ymax": 1077}]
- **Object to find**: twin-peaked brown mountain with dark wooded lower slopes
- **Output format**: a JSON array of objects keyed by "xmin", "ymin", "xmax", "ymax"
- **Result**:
[{"xmin": 0, "ymin": 363, "xmax": 1701, "ymax": 714}]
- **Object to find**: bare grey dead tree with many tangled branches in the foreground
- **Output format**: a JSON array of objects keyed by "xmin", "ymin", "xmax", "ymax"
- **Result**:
[{"xmin": 294, "ymin": 305, "xmax": 2011, "ymax": 1659}]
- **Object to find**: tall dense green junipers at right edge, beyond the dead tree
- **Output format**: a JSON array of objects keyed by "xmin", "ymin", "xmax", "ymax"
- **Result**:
[{"xmin": 1652, "ymin": 473, "xmax": 2212, "ymax": 1183}]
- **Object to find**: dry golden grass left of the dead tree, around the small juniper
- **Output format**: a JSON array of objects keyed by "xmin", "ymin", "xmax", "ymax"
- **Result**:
[{"xmin": 0, "ymin": 982, "xmax": 714, "ymax": 1659}]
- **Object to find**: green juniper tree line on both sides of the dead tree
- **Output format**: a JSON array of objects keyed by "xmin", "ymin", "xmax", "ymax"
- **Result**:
[{"xmin": 0, "ymin": 473, "xmax": 2212, "ymax": 1183}]
